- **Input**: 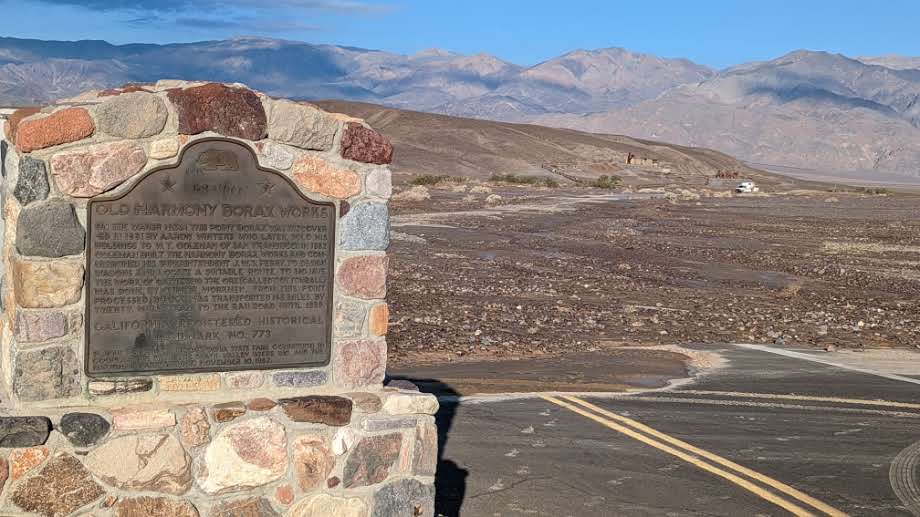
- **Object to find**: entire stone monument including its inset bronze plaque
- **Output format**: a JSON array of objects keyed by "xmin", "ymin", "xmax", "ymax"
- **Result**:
[{"xmin": 0, "ymin": 81, "xmax": 438, "ymax": 517}]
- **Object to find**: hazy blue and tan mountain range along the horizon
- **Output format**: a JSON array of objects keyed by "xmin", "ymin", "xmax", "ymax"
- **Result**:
[{"xmin": 0, "ymin": 38, "xmax": 920, "ymax": 176}]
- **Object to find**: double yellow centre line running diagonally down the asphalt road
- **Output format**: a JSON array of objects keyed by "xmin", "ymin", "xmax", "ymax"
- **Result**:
[{"xmin": 542, "ymin": 395, "xmax": 847, "ymax": 517}]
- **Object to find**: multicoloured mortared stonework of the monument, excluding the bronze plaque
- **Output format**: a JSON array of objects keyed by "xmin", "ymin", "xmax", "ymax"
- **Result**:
[{"xmin": 0, "ymin": 81, "xmax": 438, "ymax": 517}]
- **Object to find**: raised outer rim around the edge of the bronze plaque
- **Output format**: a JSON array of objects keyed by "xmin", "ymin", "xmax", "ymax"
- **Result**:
[{"xmin": 83, "ymin": 137, "xmax": 339, "ymax": 379}]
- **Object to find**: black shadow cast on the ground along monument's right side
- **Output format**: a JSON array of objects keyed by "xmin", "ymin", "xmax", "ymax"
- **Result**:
[{"xmin": 387, "ymin": 375, "xmax": 469, "ymax": 517}]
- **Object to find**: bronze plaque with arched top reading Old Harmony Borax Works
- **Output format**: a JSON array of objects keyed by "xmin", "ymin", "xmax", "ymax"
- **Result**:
[{"xmin": 85, "ymin": 139, "xmax": 336, "ymax": 376}]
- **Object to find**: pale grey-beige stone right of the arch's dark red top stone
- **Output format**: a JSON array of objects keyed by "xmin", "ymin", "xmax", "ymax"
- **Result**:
[{"xmin": 268, "ymin": 99, "xmax": 339, "ymax": 151}]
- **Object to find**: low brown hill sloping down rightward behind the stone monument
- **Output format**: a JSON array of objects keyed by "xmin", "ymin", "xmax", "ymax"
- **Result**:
[{"xmin": 316, "ymin": 101, "xmax": 775, "ymax": 185}]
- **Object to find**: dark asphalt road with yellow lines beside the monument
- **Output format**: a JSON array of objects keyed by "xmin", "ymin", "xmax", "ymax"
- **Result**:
[{"xmin": 416, "ymin": 346, "xmax": 920, "ymax": 517}]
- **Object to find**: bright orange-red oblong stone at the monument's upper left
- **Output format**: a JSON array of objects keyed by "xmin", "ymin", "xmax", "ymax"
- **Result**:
[{"xmin": 16, "ymin": 108, "xmax": 96, "ymax": 153}]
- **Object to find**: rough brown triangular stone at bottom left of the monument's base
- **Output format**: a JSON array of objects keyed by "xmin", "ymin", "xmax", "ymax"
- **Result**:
[{"xmin": 10, "ymin": 454, "xmax": 105, "ymax": 517}]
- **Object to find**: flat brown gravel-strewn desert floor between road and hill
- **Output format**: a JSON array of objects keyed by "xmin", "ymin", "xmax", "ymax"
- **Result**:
[{"xmin": 389, "ymin": 180, "xmax": 920, "ymax": 370}]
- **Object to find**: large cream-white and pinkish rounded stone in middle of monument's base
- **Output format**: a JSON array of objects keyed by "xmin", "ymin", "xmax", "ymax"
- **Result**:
[{"xmin": 197, "ymin": 417, "xmax": 288, "ymax": 495}]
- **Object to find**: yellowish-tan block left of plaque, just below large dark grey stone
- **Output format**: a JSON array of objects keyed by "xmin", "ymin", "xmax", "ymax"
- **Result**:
[{"xmin": 13, "ymin": 260, "xmax": 83, "ymax": 308}]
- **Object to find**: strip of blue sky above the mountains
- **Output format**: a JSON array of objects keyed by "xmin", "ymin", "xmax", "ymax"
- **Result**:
[{"xmin": 0, "ymin": 0, "xmax": 920, "ymax": 67}]
